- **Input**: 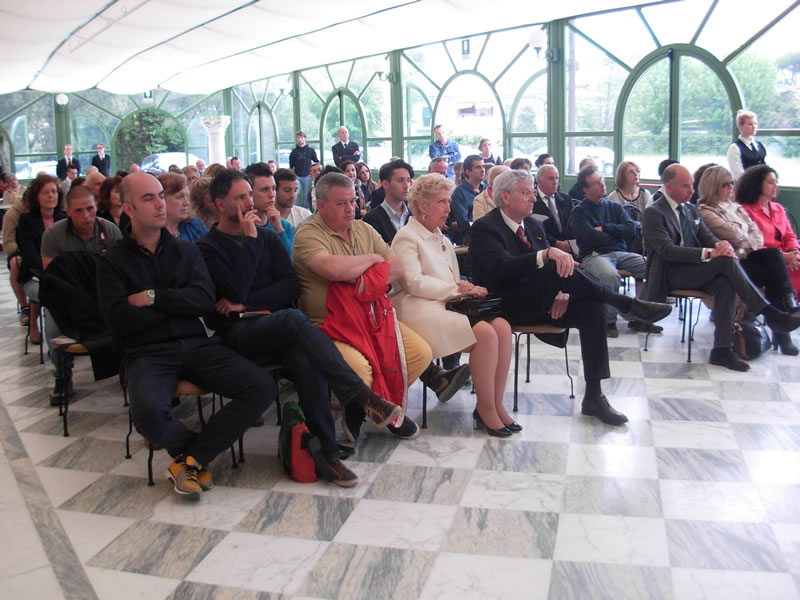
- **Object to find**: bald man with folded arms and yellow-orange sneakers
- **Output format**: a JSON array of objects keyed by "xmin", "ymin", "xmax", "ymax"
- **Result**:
[{"xmin": 97, "ymin": 172, "xmax": 277, "ymax": 499}]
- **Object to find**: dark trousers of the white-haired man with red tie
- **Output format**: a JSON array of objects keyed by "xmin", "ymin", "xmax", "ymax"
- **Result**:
[{"xmin": 505, "ymin": 261, "xmax": 620, "ymax": 381}]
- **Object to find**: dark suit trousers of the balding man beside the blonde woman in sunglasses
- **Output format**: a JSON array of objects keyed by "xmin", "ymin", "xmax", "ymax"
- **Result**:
[{"xmin": 667, "ymin": 257, "xmax": 768, "ymax": 348}]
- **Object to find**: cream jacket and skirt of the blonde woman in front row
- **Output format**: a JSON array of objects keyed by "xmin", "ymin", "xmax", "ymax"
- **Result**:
[{"xmin": 390, "ymin": 217, "xmax": 476, "ymax": 358}]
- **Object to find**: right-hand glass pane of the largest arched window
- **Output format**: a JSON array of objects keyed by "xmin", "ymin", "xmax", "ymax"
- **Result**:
[{"xmin": 679, "ymin": 56, "xmax": 731, "ymax": 177}]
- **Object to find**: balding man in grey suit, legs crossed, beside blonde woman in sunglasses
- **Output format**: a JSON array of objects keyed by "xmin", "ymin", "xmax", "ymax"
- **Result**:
[{"xmin": 642, "ymin": 164, "xmax": 800, "ymax": 371}]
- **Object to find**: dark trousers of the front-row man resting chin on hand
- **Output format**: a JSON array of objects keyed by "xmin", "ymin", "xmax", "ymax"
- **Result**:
[{"xmin": 222, "ymin": 308, "xmax": 369, "ymax": 462}]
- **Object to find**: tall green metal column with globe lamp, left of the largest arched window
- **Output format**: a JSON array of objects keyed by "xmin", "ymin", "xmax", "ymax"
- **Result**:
[{"xmin": 548, "ymin": 19, "xmax": 567, "ymax": 173}]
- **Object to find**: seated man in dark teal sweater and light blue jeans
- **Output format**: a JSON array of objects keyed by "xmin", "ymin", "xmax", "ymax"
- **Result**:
[{"xmin": 569, "ymin": 165, "xmax": 662, "ymax": 337}]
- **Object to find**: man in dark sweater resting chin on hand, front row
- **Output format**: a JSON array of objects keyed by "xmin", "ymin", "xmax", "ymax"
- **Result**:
[{"xmin": 198, "ymin": 165, "xmax": 400, "ymax": 487}]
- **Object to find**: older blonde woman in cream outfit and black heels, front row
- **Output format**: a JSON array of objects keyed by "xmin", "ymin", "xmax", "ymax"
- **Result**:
[{"xmin": 391, "ymin": 173, "xmax": 522, "ymax": 437}]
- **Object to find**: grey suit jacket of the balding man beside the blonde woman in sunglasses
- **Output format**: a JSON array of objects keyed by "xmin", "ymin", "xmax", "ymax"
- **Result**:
[{"xmin": 642, "ymin": 196, "xmax": 719, "ymax": 302}]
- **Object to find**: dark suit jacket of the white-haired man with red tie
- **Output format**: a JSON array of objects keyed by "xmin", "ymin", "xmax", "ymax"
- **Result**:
[{"xmin": 469, "ymin": 208, "xmax": 553, "ymax": 323}]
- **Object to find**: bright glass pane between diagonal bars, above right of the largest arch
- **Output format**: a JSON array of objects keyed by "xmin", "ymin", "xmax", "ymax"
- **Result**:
[{"xmin": 697, "ymin": 0, "xmax": 796, "ymax": 60}]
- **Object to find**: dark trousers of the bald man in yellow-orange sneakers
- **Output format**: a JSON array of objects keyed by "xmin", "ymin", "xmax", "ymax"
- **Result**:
[{"xmin": 125, "ymin": 337, "xmax": 276, "ymax": 465}]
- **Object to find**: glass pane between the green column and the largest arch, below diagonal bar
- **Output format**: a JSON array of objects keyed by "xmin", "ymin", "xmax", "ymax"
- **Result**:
[{"xmin": 564, "ymin": 29, "xmax": 628, "ymax": 131}]
